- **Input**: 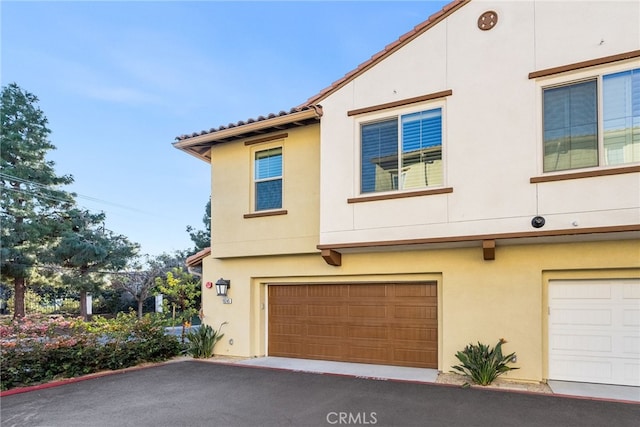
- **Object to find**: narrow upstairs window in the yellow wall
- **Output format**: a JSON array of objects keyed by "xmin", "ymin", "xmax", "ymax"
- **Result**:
[{"xmin": 254, "ymin": 147, "xmax": 282, "ymax": 211}]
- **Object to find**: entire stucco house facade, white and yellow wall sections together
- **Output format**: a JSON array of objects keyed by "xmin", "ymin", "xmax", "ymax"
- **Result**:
[{"xmin": 191, "ymin": 1, "xmax": 640, "ymax": 381}]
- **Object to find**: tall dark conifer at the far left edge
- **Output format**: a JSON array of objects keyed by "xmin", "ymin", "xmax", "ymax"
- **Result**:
[{"xmin": 0, "ymin": 83, "xmax": 74, "ymax": 317}]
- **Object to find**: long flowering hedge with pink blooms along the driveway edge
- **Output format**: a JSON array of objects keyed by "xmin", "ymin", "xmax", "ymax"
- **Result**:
[{"xmin": 0, "ymin": 313, "xmax": 181, "ymax": 390}]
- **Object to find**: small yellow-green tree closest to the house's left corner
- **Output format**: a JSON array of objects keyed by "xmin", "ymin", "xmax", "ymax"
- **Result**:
[{"xmin": 156, "ymin": 267, "xmax": 201, "ymax": 342}]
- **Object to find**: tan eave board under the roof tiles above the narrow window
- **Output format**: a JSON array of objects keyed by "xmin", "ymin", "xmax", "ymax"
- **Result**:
[{"xmin": 173, "ymin": 106, "xmax": 322, "ymax": 163}]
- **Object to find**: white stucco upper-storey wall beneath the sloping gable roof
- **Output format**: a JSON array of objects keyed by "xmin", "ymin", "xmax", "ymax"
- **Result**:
[{"xmin": 320, "ymin": 1, "xmax": 640, "ymax": 245}]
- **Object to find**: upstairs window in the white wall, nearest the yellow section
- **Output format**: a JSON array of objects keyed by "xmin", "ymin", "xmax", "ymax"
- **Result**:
[{"xmin": 360, "ymin": 108, "xmax": 443, "ymax": 193}]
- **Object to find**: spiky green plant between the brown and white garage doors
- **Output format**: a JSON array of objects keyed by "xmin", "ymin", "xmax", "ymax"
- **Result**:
[{"xmin": 452, "ymin": 338, "xmax": 519, "ymax": 385}]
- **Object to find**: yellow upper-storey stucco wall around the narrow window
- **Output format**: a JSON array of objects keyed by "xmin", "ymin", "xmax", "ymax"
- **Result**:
[{"xmin": 211, "ymin": 125, "xmax": 320, "ymax": 258}]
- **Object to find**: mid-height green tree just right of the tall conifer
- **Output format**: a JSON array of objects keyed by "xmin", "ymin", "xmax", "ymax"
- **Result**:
[{"xmin": 51, "ymin": 209, "xmax": 139, "ymax": 319}]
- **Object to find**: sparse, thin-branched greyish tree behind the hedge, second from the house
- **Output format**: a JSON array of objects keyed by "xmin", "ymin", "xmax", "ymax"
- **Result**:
[{"xmin": 111, "ymin": 254, "xmax": 184, "ymax": 319}]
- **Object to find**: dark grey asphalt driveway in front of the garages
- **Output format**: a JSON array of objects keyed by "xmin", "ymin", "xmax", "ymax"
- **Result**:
[{"xmin": 0, "ymin": 360, "xmax": 640, "ymax": 427}]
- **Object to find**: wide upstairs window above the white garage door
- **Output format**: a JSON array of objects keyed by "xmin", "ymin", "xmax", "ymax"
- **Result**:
[{"xmin": 543, "ymin": 69, "xmax": 640, "ymax": 172}]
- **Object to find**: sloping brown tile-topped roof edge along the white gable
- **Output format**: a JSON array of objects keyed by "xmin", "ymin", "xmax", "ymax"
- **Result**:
[{"xmin": 298, "ymin": 0, "xmax": 471, "ymax": 108}]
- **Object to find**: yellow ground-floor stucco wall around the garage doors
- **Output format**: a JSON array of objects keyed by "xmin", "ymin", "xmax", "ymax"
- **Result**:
[{"xmin": 203, "ymin": 240, "xmax": 640, "ymax": 381}]
